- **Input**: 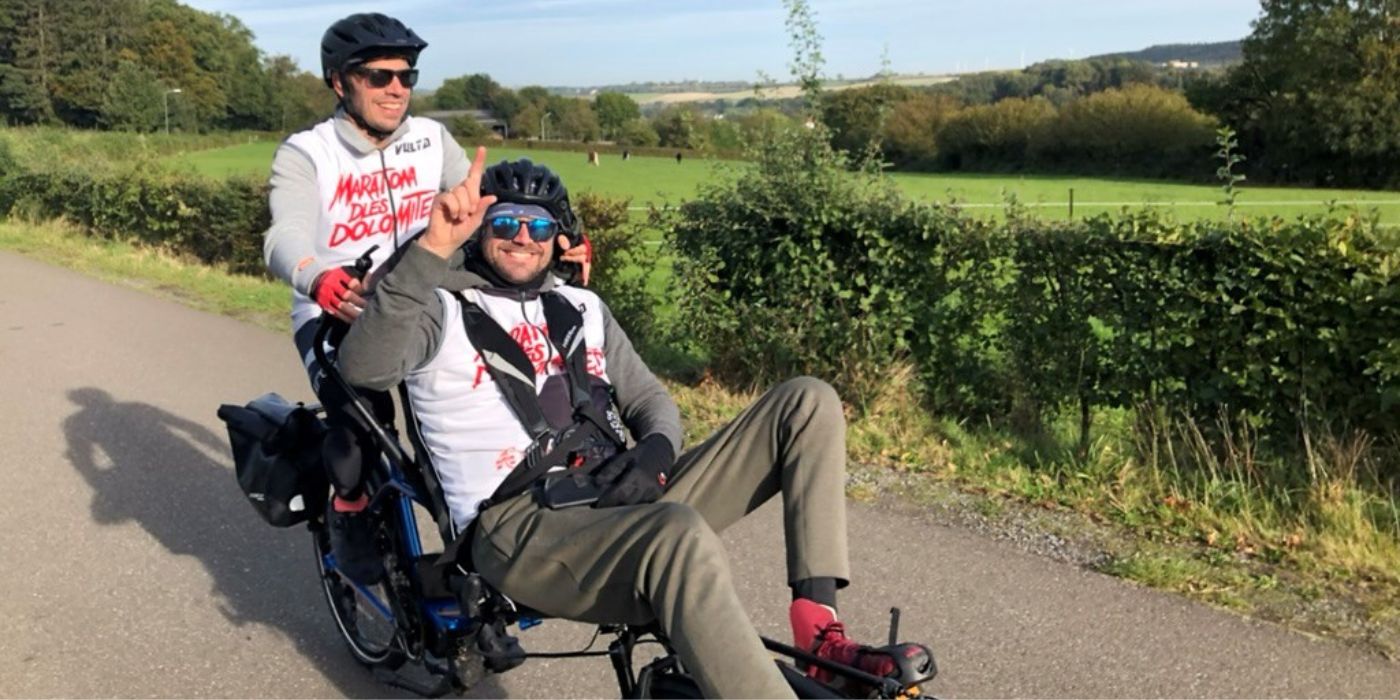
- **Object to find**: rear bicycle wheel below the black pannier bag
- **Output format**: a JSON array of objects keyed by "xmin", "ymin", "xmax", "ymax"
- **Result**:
[{"xmin": 311, "ymin": 528, "xmax": 407, "ymax": 668}]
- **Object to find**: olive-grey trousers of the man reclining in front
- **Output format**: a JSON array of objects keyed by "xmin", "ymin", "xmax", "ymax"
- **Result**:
[{"xmin": 472, "ymin": 377, "xmax": 850, "ymax": 697}]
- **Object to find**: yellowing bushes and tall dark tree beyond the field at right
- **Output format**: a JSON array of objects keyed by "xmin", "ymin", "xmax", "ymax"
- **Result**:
[{"xmin": 825, "ymin": 0, "xmax": 1400, "ymax": 188}]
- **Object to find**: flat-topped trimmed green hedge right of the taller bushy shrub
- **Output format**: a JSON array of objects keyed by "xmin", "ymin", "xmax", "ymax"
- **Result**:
[{"xmin": 914, "ymin": 214, "xmax": 1400, "ymax": 435}]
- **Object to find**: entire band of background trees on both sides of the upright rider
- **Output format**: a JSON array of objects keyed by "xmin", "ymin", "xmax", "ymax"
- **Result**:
[{"xmin": 0, "ymin": 0, "xmax": 1400, "ymax": 188}]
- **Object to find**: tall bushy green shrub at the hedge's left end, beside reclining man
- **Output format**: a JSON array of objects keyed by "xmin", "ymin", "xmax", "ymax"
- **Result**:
[{"xmin": 662, "ymin": 126, "xmax": 927, "ymax": 406}]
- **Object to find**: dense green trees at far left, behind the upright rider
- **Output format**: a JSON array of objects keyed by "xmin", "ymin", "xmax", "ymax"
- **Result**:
[{"xmin": 0, "ymin": 0, "xmax": 335, "ymax": 132}]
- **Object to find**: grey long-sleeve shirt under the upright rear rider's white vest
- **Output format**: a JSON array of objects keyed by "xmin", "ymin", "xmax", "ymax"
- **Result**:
[{"xmin": 263, "ymin": 111, "xmax": 470, "ymax": 297}]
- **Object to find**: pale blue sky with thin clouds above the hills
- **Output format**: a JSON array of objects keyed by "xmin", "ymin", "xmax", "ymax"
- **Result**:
[{"xmin": 183, "ymin": 0, "xmax": 1259, "ymax": 90}]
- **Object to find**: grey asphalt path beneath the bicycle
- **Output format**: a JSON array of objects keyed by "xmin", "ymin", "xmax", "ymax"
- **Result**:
[{"xmin": 8, "ymin": 253, "xmax": 1400, "ymax": 697}]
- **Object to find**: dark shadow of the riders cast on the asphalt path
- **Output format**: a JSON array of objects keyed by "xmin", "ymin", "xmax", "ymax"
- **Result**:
[{"xmin": 63, "ymin": 388, "xmax": 504, "ymax": 697}]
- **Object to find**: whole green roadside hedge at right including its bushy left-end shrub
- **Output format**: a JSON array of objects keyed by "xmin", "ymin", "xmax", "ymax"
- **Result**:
[{"xmin": 666, "ymin": 123, "xmax": 1400, "ymax": 453}]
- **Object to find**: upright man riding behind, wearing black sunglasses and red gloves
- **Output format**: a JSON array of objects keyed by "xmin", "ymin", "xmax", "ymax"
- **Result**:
[{"xmin": 263, "ymin": 13, "xmax": 585, "ymax": 582}]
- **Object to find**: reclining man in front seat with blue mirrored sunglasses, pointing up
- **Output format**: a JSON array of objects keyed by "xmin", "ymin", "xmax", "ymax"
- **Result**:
[{"xmin": 339, "ymin": 158, "xmax": 931, "ymax": 697}]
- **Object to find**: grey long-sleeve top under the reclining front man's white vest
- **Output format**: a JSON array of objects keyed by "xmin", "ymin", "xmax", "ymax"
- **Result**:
[{"xmin": 337, "ymin": 245, "xmax": 682, "ymax": 455}]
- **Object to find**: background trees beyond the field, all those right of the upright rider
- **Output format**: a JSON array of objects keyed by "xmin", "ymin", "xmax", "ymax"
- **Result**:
[{"xmin": 433, "ymin": 0, "xmax": 1400, "ymax": 188}]
